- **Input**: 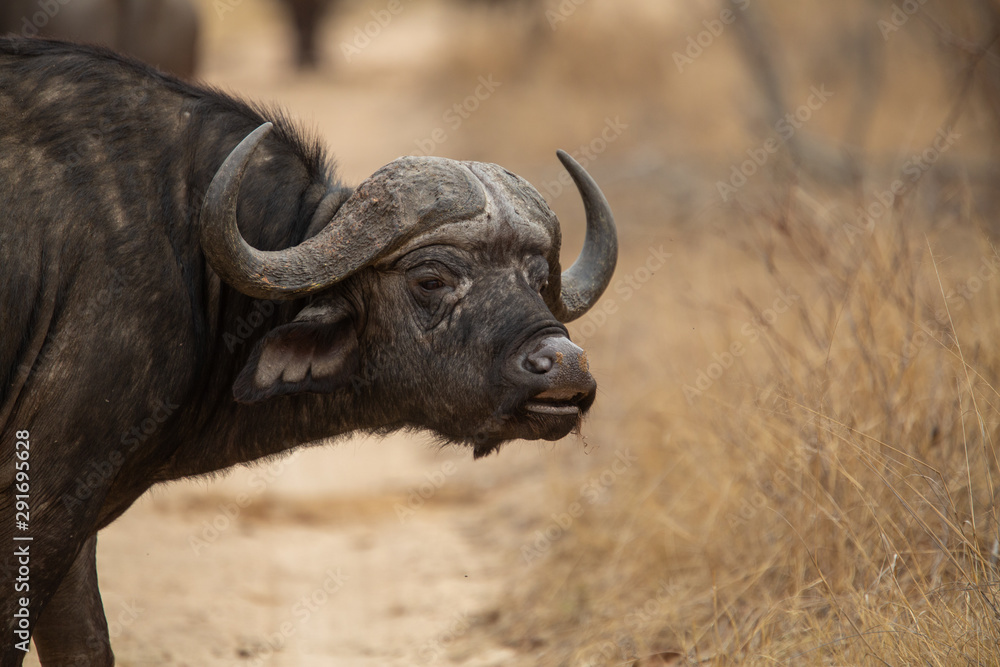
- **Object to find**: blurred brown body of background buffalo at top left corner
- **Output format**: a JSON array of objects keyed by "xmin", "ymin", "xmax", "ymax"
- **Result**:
[{"xmin": 0, "ymin": 0, "xmax": 198, "ymax": 79}]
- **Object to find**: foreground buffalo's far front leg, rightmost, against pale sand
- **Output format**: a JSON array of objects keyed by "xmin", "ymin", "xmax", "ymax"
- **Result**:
[{"xmin": 33, "ymin": 534, "xmax": 115, "ymax": 667}]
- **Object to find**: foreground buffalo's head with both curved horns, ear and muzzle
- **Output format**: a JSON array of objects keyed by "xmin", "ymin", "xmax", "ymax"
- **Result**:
[{"xmin": 202, "ymin": 123, "xmax": 618, "ymax": 456}]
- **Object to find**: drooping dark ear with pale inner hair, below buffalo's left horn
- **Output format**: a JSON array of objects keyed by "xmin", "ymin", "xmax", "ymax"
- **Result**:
[{"xmin": 233, "ymin": 307, "xmax": 360, "ymax": 403}]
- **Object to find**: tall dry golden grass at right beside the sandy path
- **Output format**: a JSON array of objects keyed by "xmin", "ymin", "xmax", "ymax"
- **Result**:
[{"xmin": 486, "ymin": 189, "xmax": 1000, "ymax": 665}]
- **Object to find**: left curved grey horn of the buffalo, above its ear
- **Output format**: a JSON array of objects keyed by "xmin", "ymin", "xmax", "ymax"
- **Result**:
[{"xmin": 201, "ymin": 123, "xmax": 486, "ymax": 299}]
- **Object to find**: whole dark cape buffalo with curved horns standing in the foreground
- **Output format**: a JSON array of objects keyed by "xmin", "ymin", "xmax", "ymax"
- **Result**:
[{"xmin": 0, "ymin": 38, "xmax": 617, "ymax": 666}]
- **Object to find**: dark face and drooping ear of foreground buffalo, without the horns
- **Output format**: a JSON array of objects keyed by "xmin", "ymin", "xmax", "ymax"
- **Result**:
[{"xmin": 228, "ymin": 194, "xmax": 594, "ymax": 457}]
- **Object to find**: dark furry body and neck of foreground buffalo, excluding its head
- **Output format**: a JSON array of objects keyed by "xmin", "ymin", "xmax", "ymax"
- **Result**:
[{"xmin": 0, "ymin": 39, "xmax": 356, "ymax": 665}]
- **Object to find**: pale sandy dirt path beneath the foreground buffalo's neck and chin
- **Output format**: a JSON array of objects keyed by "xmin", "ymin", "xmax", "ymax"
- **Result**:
[{"xmin": 25, "ymin": 436, "xmax": 572, "ymax": 667}]
